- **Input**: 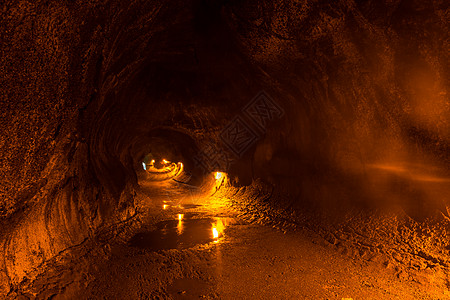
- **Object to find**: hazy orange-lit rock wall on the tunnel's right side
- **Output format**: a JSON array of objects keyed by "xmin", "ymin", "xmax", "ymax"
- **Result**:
[{"xmin": 228, "ymin": 1, "xmax": 450, "ymax": 220}]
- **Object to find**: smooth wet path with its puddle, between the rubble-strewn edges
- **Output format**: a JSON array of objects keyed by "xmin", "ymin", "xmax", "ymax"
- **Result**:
[{"xmin": 65, "ymin": 178, "xmax": 450, "ymax": 299}]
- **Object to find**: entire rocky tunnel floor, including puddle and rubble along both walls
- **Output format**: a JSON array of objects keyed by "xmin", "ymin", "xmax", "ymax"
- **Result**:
[{"xmin": 9, "ymin": 180, "xmax": 450, "ymax": 299}]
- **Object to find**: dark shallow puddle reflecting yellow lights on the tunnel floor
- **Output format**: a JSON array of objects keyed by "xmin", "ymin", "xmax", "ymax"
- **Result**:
[{"xmin": 129, "ymin": 218, "xmax": 234, "ymax": 250}]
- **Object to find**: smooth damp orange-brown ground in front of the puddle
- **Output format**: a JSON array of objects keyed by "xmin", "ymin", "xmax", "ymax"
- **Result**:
[{"xmin": 77, "ymin": 224, "xmax": 446, "ymax": 299}]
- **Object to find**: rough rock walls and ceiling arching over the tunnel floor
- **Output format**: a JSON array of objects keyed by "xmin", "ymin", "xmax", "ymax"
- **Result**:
[{"xmin": 0, "ymin": 0, "xmax": 450, "ymax": 291}]
